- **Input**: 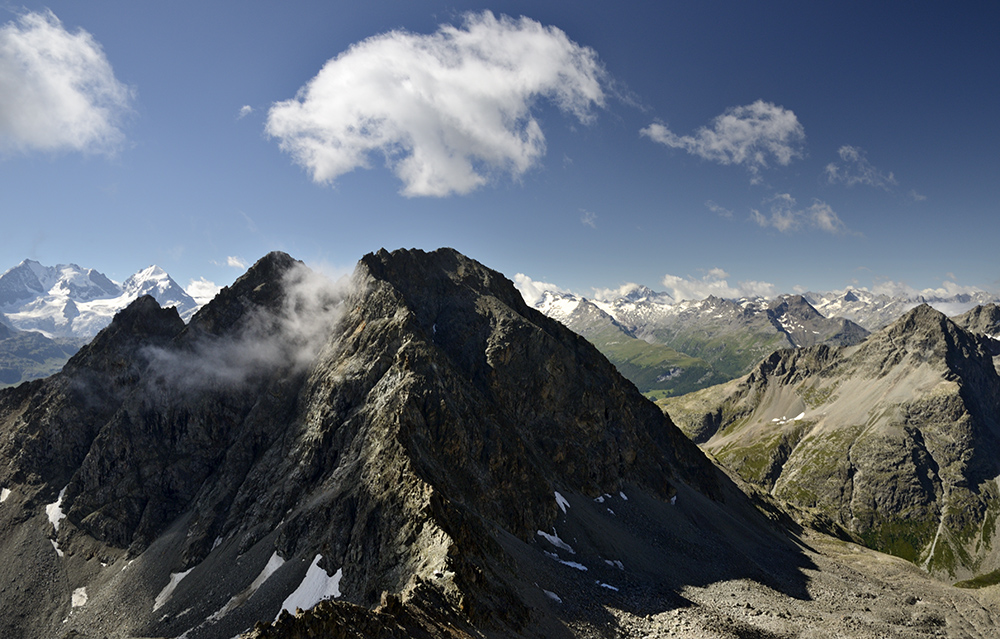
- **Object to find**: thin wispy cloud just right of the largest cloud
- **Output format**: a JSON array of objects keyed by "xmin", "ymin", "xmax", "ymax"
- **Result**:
[{"xmin": 640, "ymin": 100, "xmax": 805, "ymax": 182}]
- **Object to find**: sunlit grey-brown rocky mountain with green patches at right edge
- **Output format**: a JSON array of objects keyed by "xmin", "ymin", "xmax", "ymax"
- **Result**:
[{"xmin": 667, "ymin": 305, "xmax": 1000, "ymax": 577}]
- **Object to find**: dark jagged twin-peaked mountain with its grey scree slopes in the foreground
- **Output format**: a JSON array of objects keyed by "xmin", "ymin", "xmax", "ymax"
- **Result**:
[{"xmin": 0, "ymin": 250, "xmax": 1000, "ymax": 639}]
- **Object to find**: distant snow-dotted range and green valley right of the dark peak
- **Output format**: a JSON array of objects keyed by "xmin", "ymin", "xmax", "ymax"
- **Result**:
[{"xmin": 534, "ymin": 285, "xmax": 1000, "ymax": 398}]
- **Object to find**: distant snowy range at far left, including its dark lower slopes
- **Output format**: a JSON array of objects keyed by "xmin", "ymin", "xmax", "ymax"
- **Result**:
[{"xmin": 0, "ymin": 260, "xmax": 199, "ymax": 386}]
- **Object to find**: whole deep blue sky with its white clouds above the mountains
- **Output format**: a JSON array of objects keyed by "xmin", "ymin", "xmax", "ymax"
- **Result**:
[{"xmin": 0, "ymin": 0, "xmax": 1000, "ymax": 302}]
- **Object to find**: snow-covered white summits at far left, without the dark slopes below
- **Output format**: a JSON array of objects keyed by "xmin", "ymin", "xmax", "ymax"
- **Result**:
[{"xmin": 0, "ymin": 260, "xmax": 199, "ymax": 339}]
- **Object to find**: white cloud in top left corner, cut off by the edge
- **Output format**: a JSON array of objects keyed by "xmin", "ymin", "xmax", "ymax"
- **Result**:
[{"xmin": 0, "ymin": 12, "xmax": 132, "ymax": 153}]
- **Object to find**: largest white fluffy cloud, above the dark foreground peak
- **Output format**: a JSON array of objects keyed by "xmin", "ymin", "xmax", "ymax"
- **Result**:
[{"xmin": 267, "ymin": 12, "xmax": 605, "ymax": 196}]
